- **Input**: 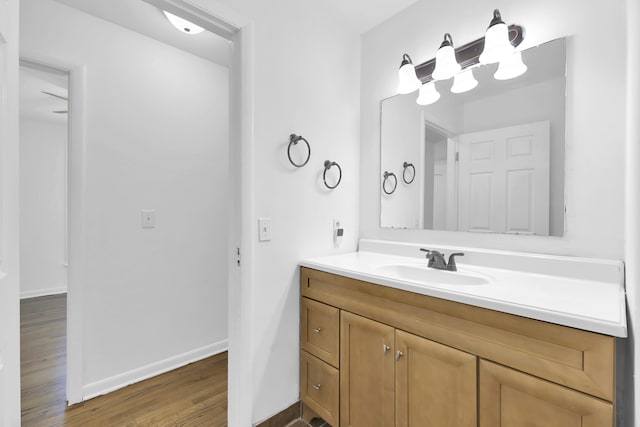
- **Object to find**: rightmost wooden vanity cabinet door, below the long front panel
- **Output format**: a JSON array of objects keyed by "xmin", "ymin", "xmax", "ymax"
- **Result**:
[{"xmin": 479, "ymin": 360, "xmax": 614, "ymax": 427}]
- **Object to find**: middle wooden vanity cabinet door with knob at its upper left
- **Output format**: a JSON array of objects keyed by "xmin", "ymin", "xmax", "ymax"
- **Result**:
[{"xmin": 395, "ymin": 331, "xmax": 477, "ymax": 427}]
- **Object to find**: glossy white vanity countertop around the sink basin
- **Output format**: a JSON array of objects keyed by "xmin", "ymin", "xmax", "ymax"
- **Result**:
[{"xmin": 300, "ymin": 243, "xmax": 627, "ymax": 337}]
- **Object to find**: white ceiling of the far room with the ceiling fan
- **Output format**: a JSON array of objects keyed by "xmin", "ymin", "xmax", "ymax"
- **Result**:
[{"xmin": 20, "ymin": 66, "xmax": 69, "ymax": 123}]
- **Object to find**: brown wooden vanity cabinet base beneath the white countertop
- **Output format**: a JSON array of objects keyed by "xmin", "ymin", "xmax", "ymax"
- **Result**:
[{"xmin": 301, "ymin": 267, "xmax": 615, "ymax": 427}]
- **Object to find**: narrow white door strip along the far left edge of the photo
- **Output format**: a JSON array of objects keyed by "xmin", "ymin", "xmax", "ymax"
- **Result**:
[{"xmin": 0, "ymin": 0, "xmax": 20, "ymax": 427}]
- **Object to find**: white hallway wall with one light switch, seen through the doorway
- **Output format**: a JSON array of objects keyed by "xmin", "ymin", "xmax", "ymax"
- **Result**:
[{"xmin": 21, "ymin": 0, "xmax": 228, "ymax": 397}]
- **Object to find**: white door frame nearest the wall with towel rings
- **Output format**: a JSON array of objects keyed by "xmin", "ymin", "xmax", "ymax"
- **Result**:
[{"xmin": 138, "ymin": 0, "xmax": 254, "ymax": 426}]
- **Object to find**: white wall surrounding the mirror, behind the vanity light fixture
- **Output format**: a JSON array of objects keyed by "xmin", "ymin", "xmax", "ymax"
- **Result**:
[{"xmin": 360, "ymin": 0, "xmax": 626, "ymax": 259}]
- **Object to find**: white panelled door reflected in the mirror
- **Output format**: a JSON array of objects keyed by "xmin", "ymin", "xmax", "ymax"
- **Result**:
[{"xmin": 458, "ymin": 121, "xmax": 549, "ymax": 236}]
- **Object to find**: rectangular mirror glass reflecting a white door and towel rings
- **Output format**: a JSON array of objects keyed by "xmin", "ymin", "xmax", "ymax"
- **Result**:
[{"xmin": 380, "ymin": 39, "xmax": 566, "ymax": 236}]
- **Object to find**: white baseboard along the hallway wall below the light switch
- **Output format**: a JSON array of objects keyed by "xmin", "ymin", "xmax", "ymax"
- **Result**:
[{"xmin": 82, "ymin": 340, "xmax": 229, "ymax": 400}]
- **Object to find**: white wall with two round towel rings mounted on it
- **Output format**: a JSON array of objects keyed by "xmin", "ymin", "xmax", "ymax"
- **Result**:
[{"xmin": 188, "ymin": 0, "xmax": 362, "ymax": 422}]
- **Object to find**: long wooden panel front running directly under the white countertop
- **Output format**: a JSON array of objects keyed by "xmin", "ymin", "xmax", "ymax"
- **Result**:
[{"xmin": 301, "ymin": 268, "xmax": 615, "ymax": 402}]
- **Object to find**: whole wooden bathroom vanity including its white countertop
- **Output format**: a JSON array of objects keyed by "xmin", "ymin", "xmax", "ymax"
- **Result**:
[{"xmin": 300, "ymin": 242, "xmax": 626, "ymax": 427}]
